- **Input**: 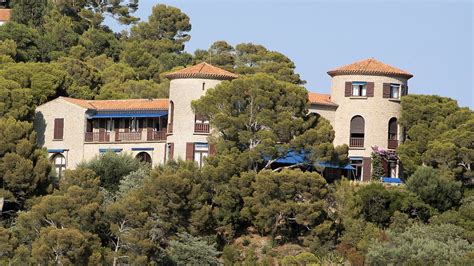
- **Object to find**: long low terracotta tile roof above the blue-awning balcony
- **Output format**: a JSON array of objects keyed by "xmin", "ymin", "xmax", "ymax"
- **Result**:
[{"xmin": 61, "ymin": 97, "xmax": 169, "ymax": 111}]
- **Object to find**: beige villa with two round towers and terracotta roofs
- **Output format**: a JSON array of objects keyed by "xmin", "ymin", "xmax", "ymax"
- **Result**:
[{"xmin": 34, "ymin": 59, "xmax": 411, "ymax": 181}]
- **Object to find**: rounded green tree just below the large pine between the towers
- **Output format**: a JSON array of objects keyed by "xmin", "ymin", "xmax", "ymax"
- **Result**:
[{"xmin": 241, "ymin": 170, "xmax": 327, "ymax": 239}]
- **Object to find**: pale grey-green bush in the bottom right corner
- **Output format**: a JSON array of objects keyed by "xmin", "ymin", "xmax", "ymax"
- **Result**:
[{"xmin": 367, "ymin": 224, "xmax": 474, "ymax": 265}]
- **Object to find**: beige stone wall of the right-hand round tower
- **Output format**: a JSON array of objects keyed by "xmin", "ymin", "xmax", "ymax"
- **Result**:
[{"xmin": 331, "ymin": 75, "xmax": 407, "ymax": 157}]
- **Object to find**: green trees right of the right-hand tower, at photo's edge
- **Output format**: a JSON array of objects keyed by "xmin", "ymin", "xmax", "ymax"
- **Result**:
[{"xmin": 397, "ymin": 95, "xmax": 474, "ymax": 182}]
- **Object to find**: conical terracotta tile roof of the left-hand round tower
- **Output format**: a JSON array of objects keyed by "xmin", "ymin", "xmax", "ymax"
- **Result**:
[{"xmin": 166, "ymin": 62, "xmax": 238, "ymax": 80}]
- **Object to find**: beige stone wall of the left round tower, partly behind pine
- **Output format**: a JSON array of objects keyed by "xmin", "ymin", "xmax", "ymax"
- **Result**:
[{"xmin": 167, "ymin": 78, "xmax": 221, "ymax": 160}]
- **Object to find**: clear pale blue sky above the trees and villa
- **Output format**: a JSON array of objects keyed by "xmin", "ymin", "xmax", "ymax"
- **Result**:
[{"xmin": 107, "ymin": 0, "xmax": 474, "ymax": 109}]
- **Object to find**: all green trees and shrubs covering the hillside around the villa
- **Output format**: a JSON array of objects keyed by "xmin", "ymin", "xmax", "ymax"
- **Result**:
[{"xmin": 0, "ymin": 0, "xmax": 474, "ymax": 265}]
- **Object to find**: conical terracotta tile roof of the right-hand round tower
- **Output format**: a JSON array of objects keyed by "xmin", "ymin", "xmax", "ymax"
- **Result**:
[{"xmin": 328, "ymin": 58, "xmax": 413, "ymax": 79}]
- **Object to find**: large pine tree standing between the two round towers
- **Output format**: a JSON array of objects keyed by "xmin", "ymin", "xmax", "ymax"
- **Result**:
[{"xmin": 192, "ymin": 74, "xmax": 347, "ymax": 170}]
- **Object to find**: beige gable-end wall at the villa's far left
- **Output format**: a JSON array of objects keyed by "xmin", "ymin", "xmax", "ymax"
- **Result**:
[{"xmin": 34, "ymin": 98, "xmax": 86, "ymax": 168}]
